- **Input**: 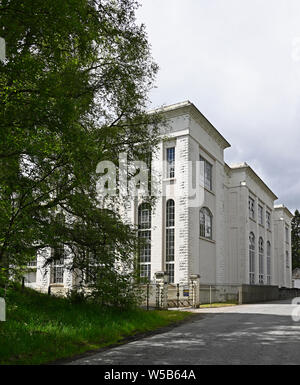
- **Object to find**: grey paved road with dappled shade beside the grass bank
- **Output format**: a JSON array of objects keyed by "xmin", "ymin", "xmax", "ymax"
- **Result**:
[{"xmin": 70, "ymin": 301, "xmax": 300, "ymax": 365}]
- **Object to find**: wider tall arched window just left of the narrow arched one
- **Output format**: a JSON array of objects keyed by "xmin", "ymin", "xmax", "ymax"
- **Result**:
[{"xmin": 138, "ymin": 203, "xmax": 151, "ymax": 281}]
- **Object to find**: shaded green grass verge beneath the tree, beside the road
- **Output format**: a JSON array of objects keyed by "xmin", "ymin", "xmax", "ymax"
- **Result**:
[{"xmin": 0, "ymin": 289, "xmax": 191, "ymax": 365}]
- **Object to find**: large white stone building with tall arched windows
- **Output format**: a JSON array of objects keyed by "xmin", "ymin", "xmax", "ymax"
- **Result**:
[{"xmin": 25, "ymin": 101, "xmax": 293, "ymax": 290}]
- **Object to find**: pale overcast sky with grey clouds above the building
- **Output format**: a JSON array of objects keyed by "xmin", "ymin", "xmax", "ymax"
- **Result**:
[{"xmin": 137, "ymin": 0, "xmax": 300, "ymax": 211}]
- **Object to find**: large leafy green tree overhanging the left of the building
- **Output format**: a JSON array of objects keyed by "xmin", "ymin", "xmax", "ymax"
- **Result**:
[{"xmin": 0, "ymin": 0, "xmax": 160, "ymax": 304}]
